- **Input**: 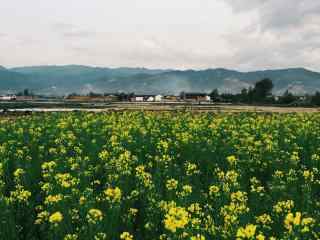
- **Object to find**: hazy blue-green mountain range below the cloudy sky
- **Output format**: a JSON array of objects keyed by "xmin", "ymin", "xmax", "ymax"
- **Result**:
[{"xmin": 0, "ymin": 65, "xmax": 320, "ymax": 96}]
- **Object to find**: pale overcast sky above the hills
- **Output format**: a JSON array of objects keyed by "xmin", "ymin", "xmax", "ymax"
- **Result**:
[{"xmin": 0, "ymin": 0, "xmax": 320, "ymax": 71}]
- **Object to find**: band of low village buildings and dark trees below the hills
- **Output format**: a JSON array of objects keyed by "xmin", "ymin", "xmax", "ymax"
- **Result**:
[{"xmin": 0, "ymin": 78, "xmax": 320, "ymax": 107}]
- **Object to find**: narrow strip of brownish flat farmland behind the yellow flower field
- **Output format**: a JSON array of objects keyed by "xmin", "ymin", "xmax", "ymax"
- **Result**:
[{"xmin": 0, "ymin": 101, "xmax": 320, "ymax": 113}]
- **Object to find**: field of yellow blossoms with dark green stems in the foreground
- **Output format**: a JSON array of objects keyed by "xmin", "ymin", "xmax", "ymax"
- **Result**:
[{"xmin": 0, "ymin": 112, "xmax": 320, "ymax": 240}]
